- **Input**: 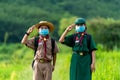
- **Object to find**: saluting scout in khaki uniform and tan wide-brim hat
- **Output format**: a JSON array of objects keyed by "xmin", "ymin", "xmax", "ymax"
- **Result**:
[{"xmin": 21, "ymin": 21, "xmax": 59, "ymax": 80}]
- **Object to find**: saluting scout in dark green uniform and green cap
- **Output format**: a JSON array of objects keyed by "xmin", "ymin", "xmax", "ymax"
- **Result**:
[{"xmin": 59, "ymin": 18, "xmax": 96, "ymax": 80}]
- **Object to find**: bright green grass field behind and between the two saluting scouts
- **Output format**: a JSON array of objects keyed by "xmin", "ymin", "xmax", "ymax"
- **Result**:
[{"xmin": 0, "ymin": 44, "xmax": 120, "ymax": 80}]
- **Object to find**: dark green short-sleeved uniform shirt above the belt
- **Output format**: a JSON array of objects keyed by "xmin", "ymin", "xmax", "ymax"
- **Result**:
[{"xmin": 63, "ymin": 34, "xmax": 96, "ymax": 53}]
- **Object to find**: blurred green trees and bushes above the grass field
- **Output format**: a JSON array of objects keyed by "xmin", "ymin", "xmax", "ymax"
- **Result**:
[{"xmin": 0, "ymin": 0, "xmax": 120, "ymax": 48}]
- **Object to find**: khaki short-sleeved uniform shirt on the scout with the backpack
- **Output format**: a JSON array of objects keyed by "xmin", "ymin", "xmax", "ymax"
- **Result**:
[{"xmin": 26, "ymin": 37, "xmax": 59, "ymax": 60}]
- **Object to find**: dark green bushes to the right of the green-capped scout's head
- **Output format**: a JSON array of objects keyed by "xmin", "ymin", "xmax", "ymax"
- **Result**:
[{"xmin": 88, "ymin": 18, "xmax": 120, "ymax": 49}]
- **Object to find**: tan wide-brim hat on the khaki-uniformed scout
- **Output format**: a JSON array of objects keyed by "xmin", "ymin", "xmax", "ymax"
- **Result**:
[{"xmin": 35, "ymin": 21, "xmax": 54, "ymax": 32}]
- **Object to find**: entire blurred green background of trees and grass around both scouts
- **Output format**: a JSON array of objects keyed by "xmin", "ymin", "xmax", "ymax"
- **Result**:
[{"xmin": 0, "ymin": 0, "xmax": 120, "ymax": 80}]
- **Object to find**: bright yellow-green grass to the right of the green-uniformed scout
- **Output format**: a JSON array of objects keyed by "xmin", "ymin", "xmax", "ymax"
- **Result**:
[{"xmin": 93, "ymin": 50, "xmax": 120, "ymax": 80}]
